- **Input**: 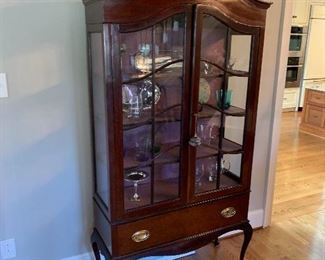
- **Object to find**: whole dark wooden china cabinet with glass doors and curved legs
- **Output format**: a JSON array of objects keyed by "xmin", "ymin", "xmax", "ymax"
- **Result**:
[{"xmin": 84, "ymin": 0, "xmax": 270, "ymax": 259}]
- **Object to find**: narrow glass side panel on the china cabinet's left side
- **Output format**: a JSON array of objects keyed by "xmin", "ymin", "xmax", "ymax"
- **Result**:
[{"xmin": 90, "ymin": 33, "xmax": 109, "ymax": 205}]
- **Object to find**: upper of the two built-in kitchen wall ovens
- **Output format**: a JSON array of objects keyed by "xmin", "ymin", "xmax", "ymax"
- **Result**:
[{"xmin": 289, "ymin": 26, "xmax": 308, "ymax": 57}]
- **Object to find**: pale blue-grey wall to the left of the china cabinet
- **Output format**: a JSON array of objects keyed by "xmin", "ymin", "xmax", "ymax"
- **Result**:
[{"xmin": 0, "ymin": 0, "xmax": 92, "ymax": 260}]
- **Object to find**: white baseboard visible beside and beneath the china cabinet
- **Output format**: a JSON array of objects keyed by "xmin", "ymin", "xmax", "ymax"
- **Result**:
[{"xmin": 61, "ymin": 209, "xmax": 264, "ymax": 260}]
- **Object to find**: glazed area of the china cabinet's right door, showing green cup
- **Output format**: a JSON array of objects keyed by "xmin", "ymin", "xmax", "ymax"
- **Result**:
[{"xmin": 189, "ymin": 11, "xmax": 252, "ymax": 195}]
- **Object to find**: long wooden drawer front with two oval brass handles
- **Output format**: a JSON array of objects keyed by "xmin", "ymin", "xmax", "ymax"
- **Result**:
[{"xmin": 113, "ymin": 194, "xmax": 249, "ymax": 256}]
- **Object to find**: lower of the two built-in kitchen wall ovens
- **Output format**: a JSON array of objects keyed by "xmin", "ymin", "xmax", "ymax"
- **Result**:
[{"xmin": 285, "ymin": 57, "xmax": 303, "ymax": 88}]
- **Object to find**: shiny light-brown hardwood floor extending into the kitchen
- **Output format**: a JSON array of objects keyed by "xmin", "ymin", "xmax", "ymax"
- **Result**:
[{"xmin": 186, "ymin": 112, "xmax": 325, "ymax": 260}]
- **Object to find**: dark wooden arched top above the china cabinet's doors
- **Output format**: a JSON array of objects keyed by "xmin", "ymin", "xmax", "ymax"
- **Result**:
[{"xmin": 84, "ymin": 0, "xmax": 271, "ymax": 27}]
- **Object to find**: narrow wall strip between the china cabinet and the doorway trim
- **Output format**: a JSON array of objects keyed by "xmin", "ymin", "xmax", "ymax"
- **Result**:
[{"xmin": 250, "ymin": 0, "xmax": 284, "ymax": 217}]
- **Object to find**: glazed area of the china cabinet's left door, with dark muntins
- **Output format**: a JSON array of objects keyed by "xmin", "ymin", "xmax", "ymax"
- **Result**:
[{"xmin": 119, "ymin": 14, "xmax": 186, "ymax": 210}]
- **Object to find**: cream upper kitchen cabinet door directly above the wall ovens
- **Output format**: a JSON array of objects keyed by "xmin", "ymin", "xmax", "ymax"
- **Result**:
[{"xmin": 292, "ymin": 0, "xmax": 311, "ymax": 26}]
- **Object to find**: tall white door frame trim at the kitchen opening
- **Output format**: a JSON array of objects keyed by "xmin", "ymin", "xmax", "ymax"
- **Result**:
[{"xmin": 263, "ymin": 1, "xmax": 293, "ymax": 227}]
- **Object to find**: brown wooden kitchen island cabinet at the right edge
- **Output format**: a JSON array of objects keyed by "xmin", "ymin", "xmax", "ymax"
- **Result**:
[{"xmin": 300, "ymin": 88, "xmax": 325, "ymax": 138}]
